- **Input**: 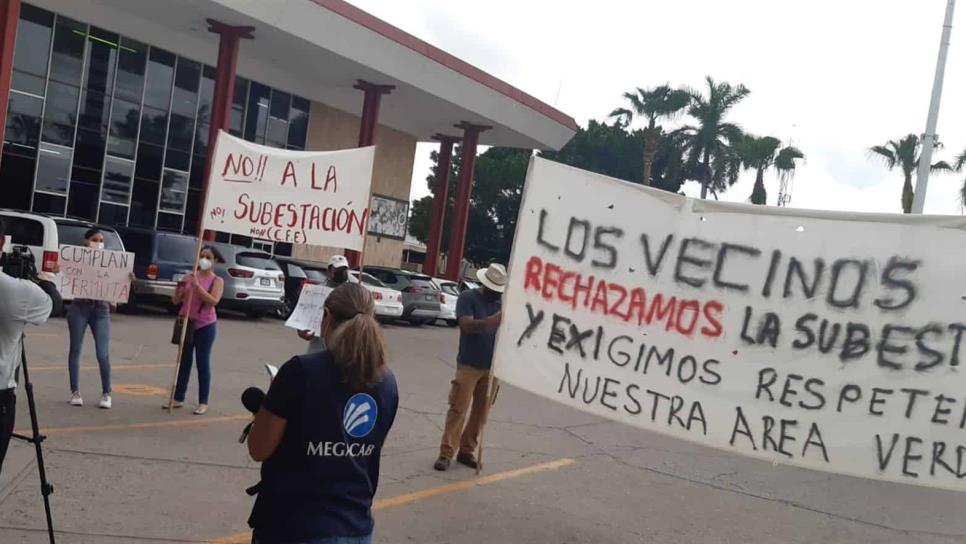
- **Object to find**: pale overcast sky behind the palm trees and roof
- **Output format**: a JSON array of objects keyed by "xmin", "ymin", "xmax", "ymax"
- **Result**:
[{"xmin": 350, "ymin": 0, "xmax": 966, "ymax": 214}]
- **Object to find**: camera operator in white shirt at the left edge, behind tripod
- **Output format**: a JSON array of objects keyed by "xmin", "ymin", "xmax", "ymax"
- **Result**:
[{"xmin": 0, "ymin": 218, "xmax": 62, "ymax": 470}]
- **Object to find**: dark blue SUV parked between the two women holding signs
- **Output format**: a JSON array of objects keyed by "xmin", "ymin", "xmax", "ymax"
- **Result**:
[{"xmin": 114, "ymin": 227, "xmax": 198, "ymax": 309}]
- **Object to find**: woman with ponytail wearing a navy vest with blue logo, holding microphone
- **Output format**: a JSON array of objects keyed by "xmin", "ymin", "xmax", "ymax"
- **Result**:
[{"xmin": 248, "ymin": 283, "xmax": 399, "ymax": 544}]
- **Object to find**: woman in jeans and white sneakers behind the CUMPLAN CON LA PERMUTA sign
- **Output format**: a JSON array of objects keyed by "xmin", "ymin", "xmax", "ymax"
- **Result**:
[{"xmin": 67, "ymin": 228, "xmax": 129, "ymax": 410}]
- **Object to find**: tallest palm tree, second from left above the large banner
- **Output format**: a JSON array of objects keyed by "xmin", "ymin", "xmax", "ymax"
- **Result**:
[{"xmin": 681, "ymin": 76, "xmax": 751, "ymax": 198}]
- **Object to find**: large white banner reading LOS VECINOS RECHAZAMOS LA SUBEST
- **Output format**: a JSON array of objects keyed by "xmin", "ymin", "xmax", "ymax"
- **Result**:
[{"xmin": 494, "ymin": 159, "xmax": 966, "ymax": 491}]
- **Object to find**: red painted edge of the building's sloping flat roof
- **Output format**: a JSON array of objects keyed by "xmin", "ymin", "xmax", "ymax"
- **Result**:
[{"xmin": 312, "ymin": 0, "xmax": 577, "ymax": 131}]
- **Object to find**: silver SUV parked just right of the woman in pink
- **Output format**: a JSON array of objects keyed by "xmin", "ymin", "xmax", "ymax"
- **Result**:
[{"xmin": 209, "ymin": 243, "xmax": 285, "ymax": 318}]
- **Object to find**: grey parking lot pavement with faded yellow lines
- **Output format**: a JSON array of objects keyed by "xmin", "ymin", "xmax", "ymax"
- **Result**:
[{"xmin": 0, "ymin": 312, "xmax": 966, "ymax": 544}]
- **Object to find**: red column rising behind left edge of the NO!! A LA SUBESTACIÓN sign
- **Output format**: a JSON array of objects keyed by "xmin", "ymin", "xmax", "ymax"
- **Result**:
[{"xmin": 198, "ymin": 19, "xmax": 255, "ymax": 240}]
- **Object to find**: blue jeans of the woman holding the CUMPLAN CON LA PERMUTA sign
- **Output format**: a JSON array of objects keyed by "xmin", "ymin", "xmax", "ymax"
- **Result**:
[{"xmin": 67, "ymin": 301, "xmax": 111, "ymax": 395}]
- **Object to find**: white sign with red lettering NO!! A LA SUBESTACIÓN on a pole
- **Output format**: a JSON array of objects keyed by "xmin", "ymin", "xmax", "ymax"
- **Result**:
[{"xmin": 203, "ymin": 132, "xmax": 375, "ymax": 251}]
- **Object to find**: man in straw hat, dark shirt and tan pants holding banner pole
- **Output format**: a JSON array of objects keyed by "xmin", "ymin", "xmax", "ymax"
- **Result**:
[{"xmin": 433, "ymin": 264, "xmax": 506, "ymax": 470}]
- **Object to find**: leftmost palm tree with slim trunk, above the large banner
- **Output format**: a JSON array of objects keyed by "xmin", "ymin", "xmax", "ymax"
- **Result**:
[{"xmin": 610, "ymin": 85, "xmax": 691, "ymax": 185}]
